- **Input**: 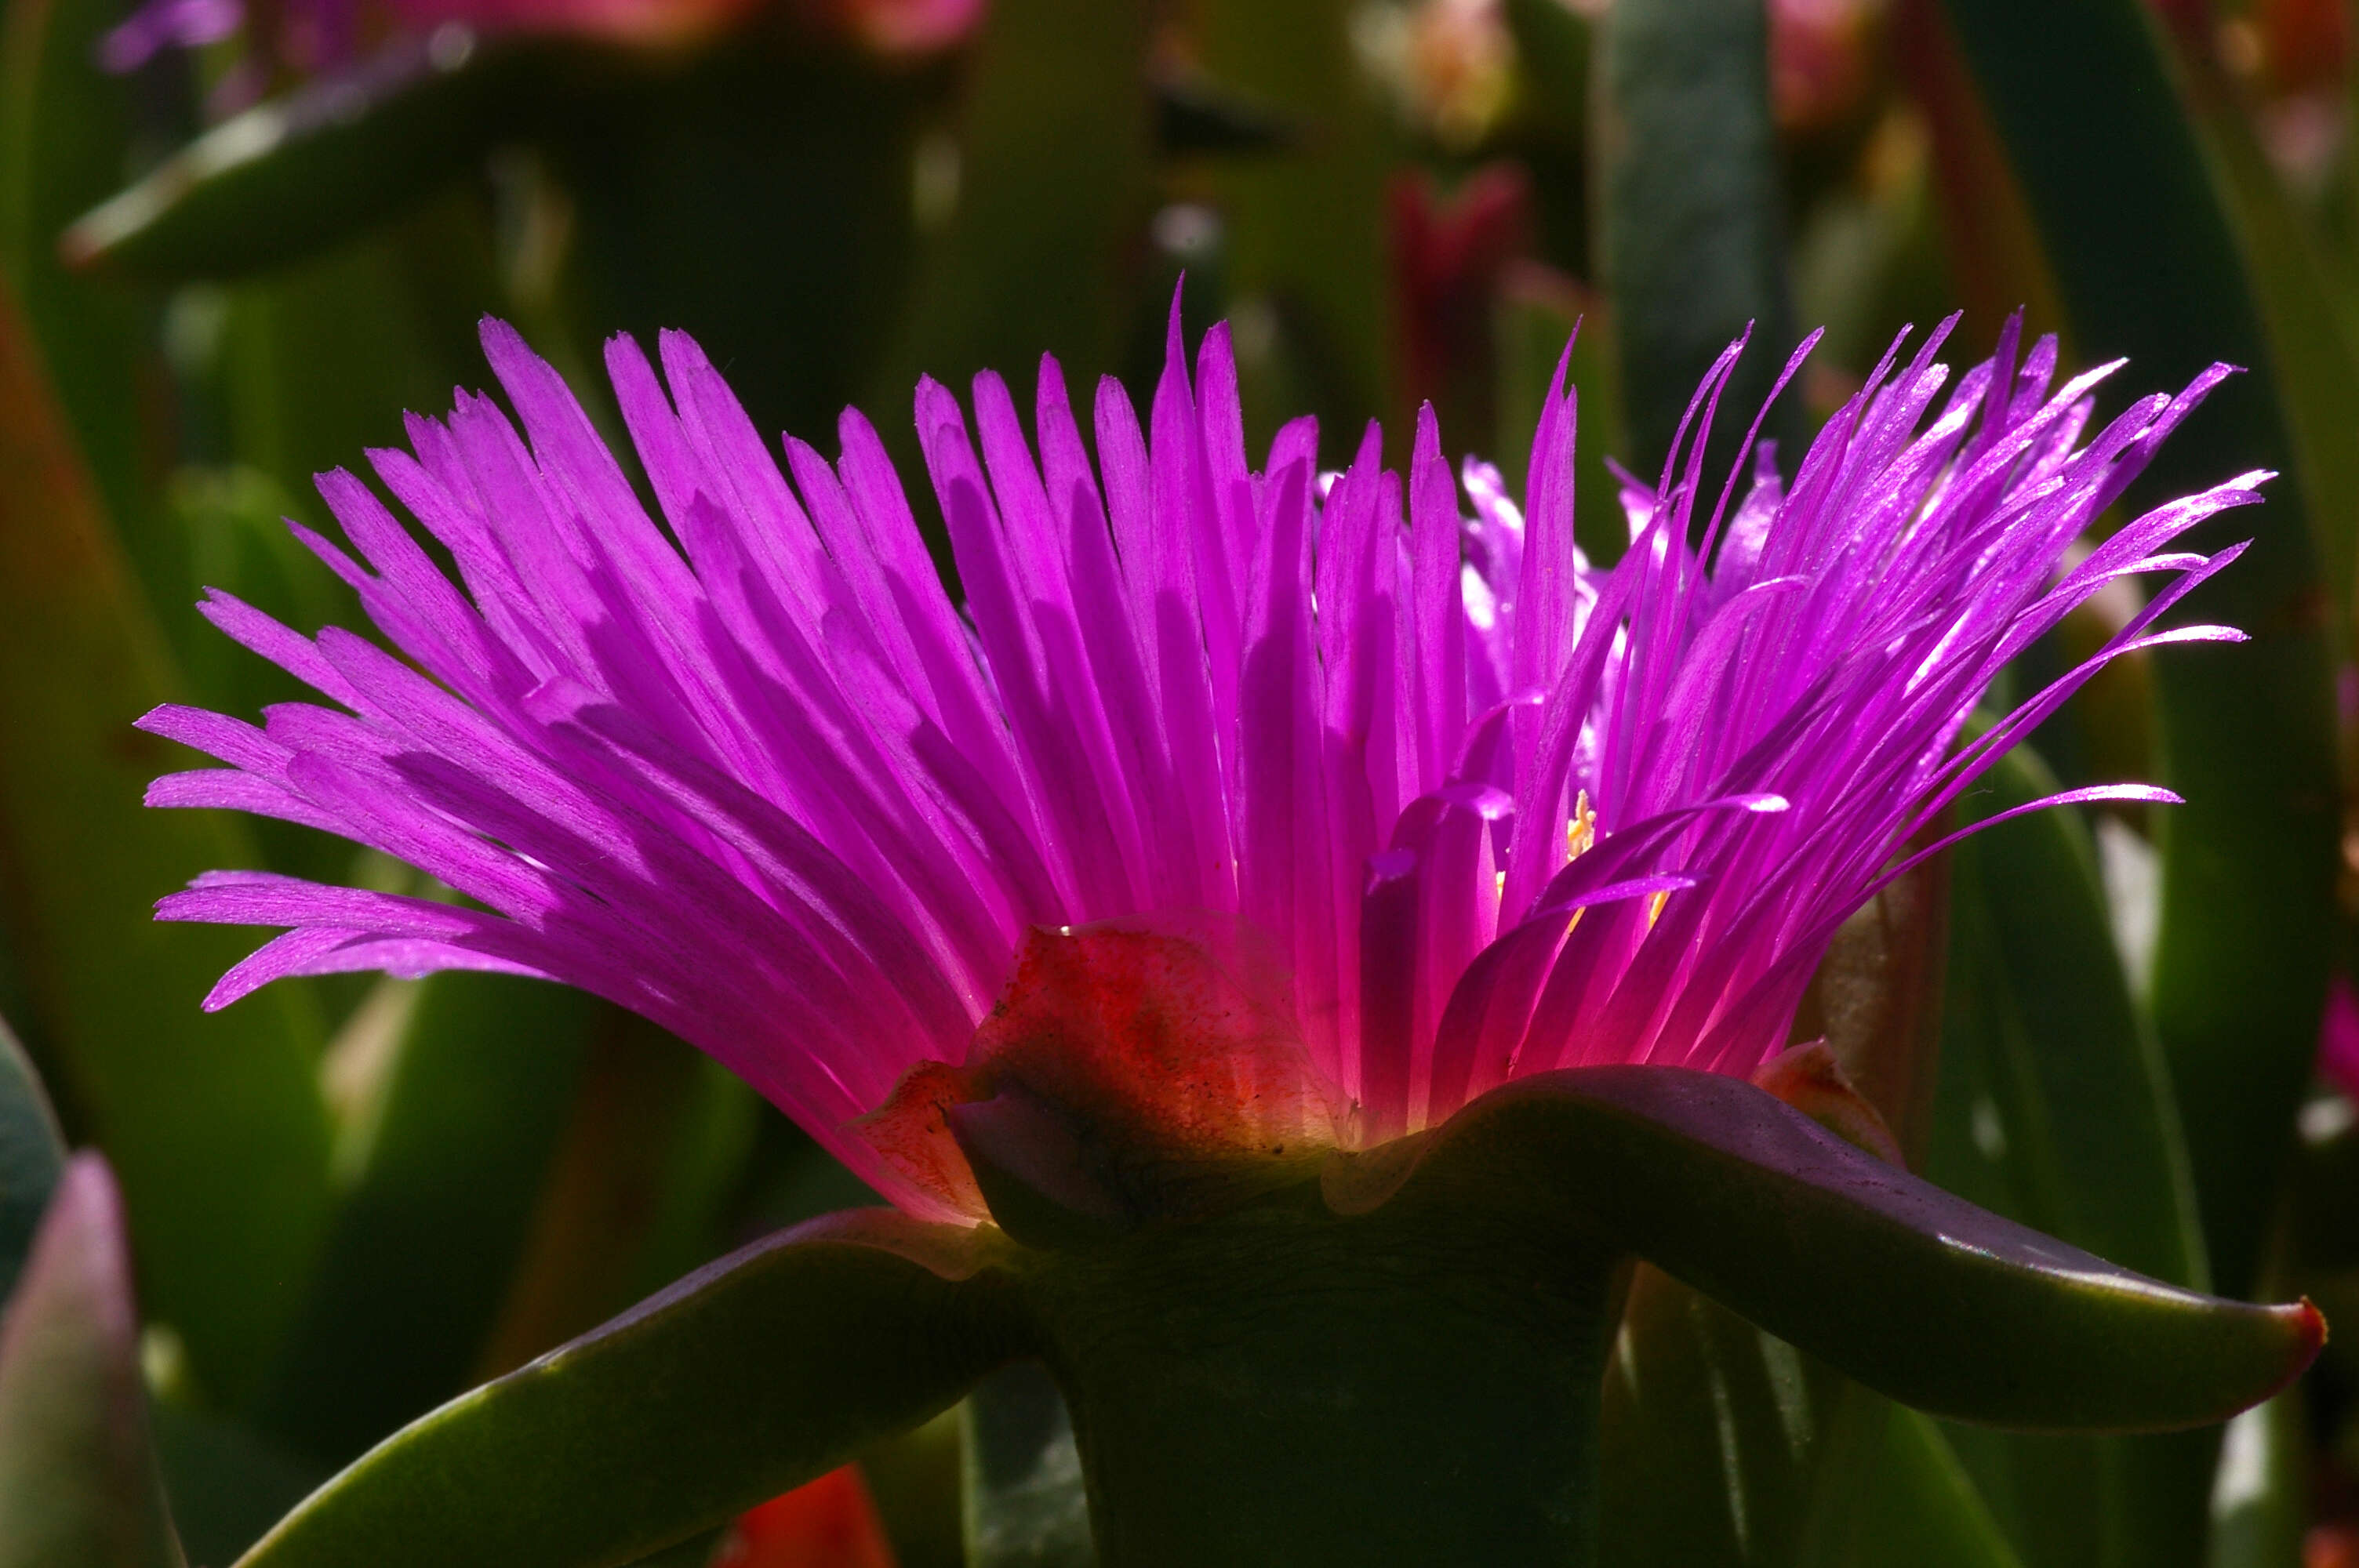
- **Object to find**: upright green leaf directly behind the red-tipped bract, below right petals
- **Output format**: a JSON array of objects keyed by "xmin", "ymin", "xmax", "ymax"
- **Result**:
[{"xmin": 1930, "ymin": 750, "xmax": 2208, "ymax": 1568}]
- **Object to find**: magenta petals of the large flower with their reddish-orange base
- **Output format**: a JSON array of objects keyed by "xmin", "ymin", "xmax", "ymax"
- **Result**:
[{"xmin": 141, "ymin": 301, "xmax": 2265, "ymax": 1219}]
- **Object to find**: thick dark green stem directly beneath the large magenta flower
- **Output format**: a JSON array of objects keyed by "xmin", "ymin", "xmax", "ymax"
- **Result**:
[{"xmin": 1034, "ymin": 1189, "xmax": 1613, "ymax": 1568}]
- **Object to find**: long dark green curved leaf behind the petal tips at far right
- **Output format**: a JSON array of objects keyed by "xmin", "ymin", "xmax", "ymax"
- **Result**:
[{"xmin": 1949, "ymin": 0, "xmax": 2338, "ymax": 1292}]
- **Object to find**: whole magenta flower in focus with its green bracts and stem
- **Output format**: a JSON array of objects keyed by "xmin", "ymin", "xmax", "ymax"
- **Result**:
[{"xmin": 157, "ymin": 311, "xmax": 2324, "ymax": 1568}]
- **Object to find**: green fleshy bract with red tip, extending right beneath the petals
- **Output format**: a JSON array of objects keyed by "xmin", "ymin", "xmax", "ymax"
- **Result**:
[{"xmin": 1331, "ymin": 1065, "xmax": 2326, "ymax": 1432}]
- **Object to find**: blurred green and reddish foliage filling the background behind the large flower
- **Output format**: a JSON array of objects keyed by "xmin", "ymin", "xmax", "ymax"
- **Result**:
[{"xmin": 0, "ymin": 0, "xmax": 2359, "ymax": 1568}]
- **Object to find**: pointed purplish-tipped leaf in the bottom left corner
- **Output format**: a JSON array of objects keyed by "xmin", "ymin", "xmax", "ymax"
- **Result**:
[{"xmin": 0, "ymin": 1156, "xmax": 187, "ymax": 1568}]
